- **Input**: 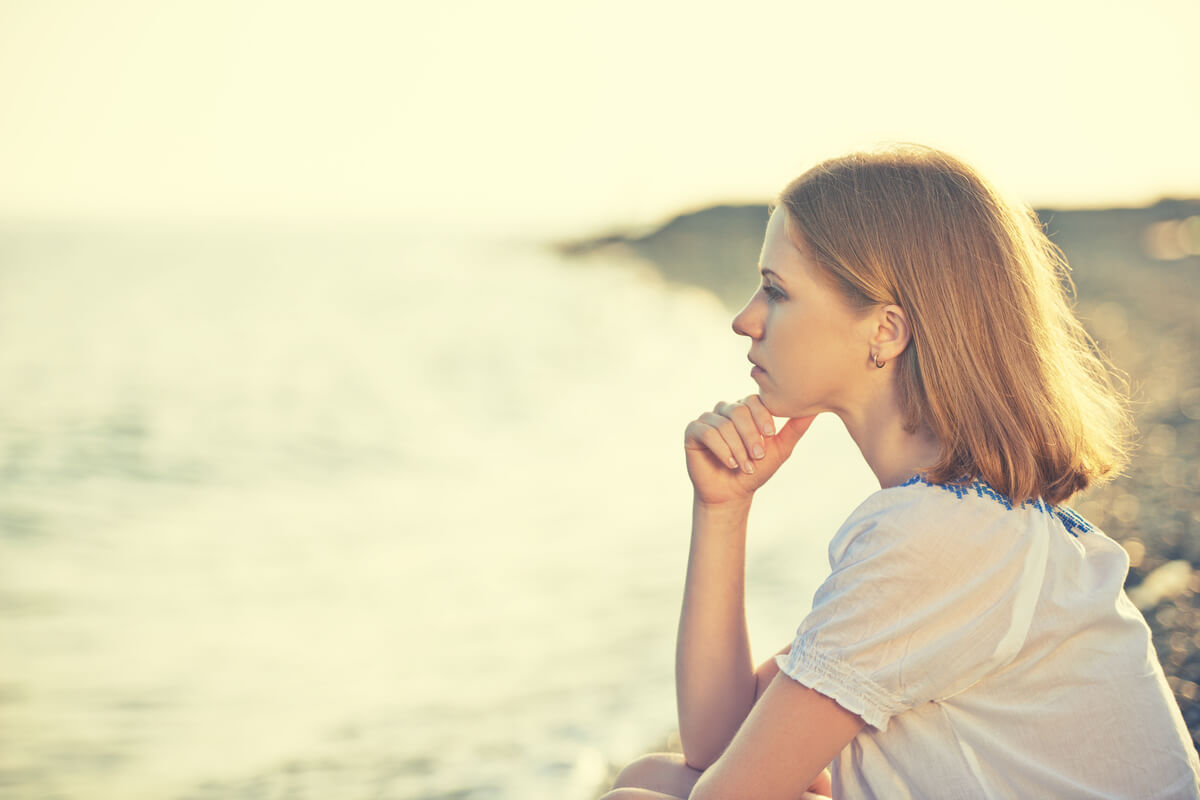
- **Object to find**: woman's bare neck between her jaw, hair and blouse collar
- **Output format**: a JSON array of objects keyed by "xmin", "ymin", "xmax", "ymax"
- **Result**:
[{"xmin": 839, "ymin": 392, "xmax": 941, "ymax": 489}]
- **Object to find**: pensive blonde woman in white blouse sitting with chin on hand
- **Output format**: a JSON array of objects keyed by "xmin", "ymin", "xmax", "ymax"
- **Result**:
[{"xmin": 606, "ymin": 146, "xmax": 1200, "ymax": 800}]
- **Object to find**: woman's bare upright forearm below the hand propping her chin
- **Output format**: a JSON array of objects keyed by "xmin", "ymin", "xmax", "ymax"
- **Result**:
[{"xmin": 676, "ymin": 501, "xmax": 755, "ymax": 769}]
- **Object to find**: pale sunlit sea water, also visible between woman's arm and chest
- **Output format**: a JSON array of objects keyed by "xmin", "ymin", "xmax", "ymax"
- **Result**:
[{"xmin": 0, "ymin": 225, "xmax": 874, "ymax": 800}]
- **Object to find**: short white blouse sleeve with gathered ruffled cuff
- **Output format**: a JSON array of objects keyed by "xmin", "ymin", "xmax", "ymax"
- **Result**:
[{"xmin": 776, "ymin": 489, "xmax": 1050, "ymax": 729}]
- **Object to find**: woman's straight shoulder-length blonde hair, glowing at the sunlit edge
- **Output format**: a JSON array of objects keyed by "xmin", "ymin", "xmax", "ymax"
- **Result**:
[{"xmin": 779, "ymin": 145, "xmax": 1133, "ymax": 504}]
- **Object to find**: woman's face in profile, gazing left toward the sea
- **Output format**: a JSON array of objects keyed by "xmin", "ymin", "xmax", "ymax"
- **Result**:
[{"xmin": 733, "ymin": 207, "xmax": 871, "ymax": 416}]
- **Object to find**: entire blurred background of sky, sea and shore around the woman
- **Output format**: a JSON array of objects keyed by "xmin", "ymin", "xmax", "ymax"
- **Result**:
[{"xmin": 0, "ymin": 0, "xmax": 1200, "ymax": 800}]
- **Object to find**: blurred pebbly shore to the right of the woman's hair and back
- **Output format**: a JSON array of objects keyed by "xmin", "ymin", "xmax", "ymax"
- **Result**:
[{"xmin": 1045, "ymin": 203, "xmax": 1200, "ymax": 746}]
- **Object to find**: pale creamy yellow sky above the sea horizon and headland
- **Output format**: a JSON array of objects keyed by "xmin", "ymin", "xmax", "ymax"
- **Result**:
[{"xmin": 0, "ymin": 0, "xmax": 1200, "ymax": 234}]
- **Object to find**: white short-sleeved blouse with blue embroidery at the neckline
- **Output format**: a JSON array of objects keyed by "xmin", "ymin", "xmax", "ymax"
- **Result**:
[{"xmin": 778, "ymin": 477, "xmax": 1200, "ymax": 800}]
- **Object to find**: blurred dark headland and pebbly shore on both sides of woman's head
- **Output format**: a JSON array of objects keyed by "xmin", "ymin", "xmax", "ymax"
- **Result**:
[{"xmin": 556, "ymin": 199, "xmax": 1200, "ymax": 758}]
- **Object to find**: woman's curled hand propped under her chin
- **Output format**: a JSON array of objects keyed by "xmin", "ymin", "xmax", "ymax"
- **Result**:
[{"xmin": 683, "ymin": 395, "xmax": 814, "ymax": 505}]
